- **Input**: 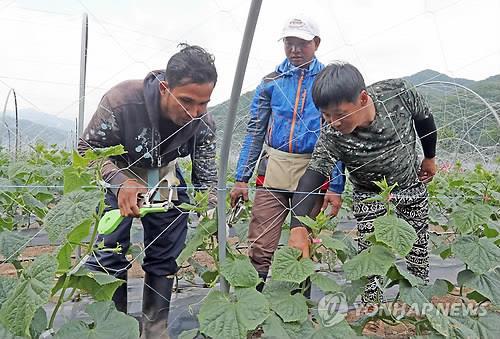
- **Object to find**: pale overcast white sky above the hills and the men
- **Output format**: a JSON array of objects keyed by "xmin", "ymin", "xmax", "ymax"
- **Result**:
[{"xmin": 0, "ymin": 0, "xmax": 500, "ymax": 126}]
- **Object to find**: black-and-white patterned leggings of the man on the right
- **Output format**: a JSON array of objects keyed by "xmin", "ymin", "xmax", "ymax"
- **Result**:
[{"xmin": 353, "ymin": 182, "xmax": 429, "ymax": 304}]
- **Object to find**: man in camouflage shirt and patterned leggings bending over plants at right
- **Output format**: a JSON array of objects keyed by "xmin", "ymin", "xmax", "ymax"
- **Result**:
[{"xmin": 289, "ymin": 63, "xmax": 437, "ymax": 302}]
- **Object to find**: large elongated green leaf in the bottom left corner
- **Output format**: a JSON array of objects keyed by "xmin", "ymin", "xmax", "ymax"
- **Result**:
[{"xmin": 0, "ymin": 254, "xmax": 57, "ymax": 336}]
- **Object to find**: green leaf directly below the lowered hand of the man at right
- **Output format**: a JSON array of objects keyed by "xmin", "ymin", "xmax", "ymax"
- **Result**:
[{"xmin": 271, "ymin": 246, "xmax": 314, "ymax": 283}]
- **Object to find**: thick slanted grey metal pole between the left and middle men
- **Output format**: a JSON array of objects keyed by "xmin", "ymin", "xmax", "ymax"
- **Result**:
[{"xmin": 217, "ymin": 0, "xmax": 262, "ymax": 292}]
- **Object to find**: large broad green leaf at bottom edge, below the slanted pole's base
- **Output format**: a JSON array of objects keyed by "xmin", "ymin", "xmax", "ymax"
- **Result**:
[{"xmin": 198, "ymin": 287, "xmax": 270, "ymax": 339}]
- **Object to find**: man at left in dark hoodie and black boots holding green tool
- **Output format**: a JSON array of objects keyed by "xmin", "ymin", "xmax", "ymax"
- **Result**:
[{"xmin": 78, "ymin": 44, "xmax": 217, "ymax": 338}]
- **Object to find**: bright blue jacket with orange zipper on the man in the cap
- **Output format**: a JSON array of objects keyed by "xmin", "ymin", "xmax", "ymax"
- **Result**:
[{"xmin": 235, "ymin": 58, "xmax": 345, "ymax": 193}]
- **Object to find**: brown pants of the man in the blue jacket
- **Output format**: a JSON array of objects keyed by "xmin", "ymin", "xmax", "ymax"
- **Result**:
[{"xmin": 248, "ymin": 188, "xmax": 323, "ymax": 272}]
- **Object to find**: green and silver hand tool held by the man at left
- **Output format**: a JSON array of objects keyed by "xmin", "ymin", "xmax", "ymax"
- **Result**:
[{"xmin": 97, "ymin": 175, "xmax": 179, "ymax": 234}]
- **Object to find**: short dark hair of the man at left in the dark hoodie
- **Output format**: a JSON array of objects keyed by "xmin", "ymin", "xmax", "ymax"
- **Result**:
[{"xmin": 165, "ymin": 43, "xmax": 217, "ymax": 88}]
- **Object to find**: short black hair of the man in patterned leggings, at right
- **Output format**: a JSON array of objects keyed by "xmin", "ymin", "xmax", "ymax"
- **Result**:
[{"xmin": 312, "ymin": 62, "xmax": 366, "ymax": 108}]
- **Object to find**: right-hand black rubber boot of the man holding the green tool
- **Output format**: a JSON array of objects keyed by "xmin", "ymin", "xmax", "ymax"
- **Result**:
[{"xmin": 141, "ymin": 273, "xmax": 174, "ymax": 339}]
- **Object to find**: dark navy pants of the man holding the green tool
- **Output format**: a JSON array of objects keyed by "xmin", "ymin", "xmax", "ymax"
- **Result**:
[{"xmin": 85, "ymin": 172, "xmax": 189, "ymax": 277}]
